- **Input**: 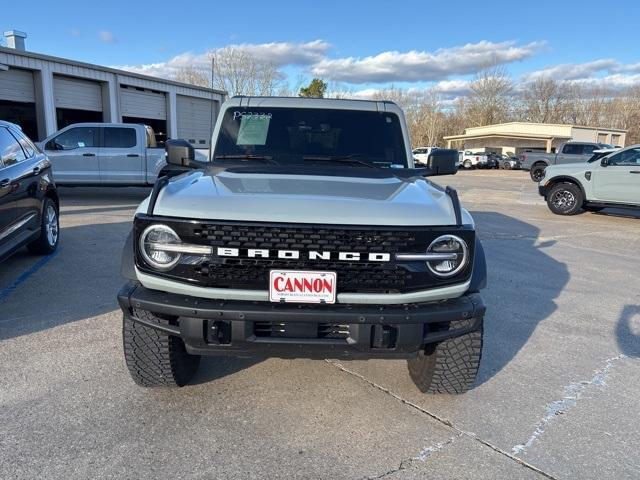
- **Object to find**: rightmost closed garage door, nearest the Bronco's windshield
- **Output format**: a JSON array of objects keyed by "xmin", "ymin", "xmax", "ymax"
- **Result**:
[{"xmin": 176, "ymin": 95, "xmax": 216, "ymax": 148}]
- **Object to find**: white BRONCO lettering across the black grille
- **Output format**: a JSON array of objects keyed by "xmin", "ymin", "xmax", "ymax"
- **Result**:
[{"xmin": 217, "ymin": 247, "xmax": 391, "ymax": 262}]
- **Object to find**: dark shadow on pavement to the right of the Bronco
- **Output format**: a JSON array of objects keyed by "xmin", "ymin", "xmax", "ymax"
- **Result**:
[{"xmin": 472, "ymin": 211, "xmax": 570, "ymax": 385}]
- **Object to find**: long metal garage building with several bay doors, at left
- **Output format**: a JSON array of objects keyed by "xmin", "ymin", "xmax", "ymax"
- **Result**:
[{"xmin": 0, "ymin": 31, "xmax": 225, "ymax": 149}]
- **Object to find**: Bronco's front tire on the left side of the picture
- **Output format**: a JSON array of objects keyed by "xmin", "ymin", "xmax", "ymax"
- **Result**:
[{"xmin": 122, "ymin": 310, "xmax": 200, "ymax": 387}]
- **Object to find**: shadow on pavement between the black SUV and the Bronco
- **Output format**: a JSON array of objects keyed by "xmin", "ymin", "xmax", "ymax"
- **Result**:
[{"xmin": 0, "ymin": 221, "xmax": 131, "ymax": 340}]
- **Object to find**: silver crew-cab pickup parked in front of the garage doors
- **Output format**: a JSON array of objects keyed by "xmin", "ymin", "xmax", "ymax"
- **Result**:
[{"xmin": 39, "ymin": 123, "xmax": 166, "ymax": 185}]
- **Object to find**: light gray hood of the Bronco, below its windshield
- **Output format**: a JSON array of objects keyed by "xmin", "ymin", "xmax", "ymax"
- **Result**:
[{"xmin": 147, "ymin": 170, "xmax": 462, "ymax": 226}]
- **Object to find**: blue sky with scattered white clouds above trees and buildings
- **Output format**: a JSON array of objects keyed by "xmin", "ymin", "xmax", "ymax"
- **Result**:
[{"xmin": 5, "ymin": 0, "xmax": 640, "ymax": 96}]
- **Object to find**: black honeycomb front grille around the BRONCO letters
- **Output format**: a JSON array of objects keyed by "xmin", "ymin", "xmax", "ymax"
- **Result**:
[{"xmin": 135, "ymin": 215, "xmax": 475, "ymax": 293}]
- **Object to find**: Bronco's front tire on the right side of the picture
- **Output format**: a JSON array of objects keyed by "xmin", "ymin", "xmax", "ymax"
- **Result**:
[{"xmin": 407, "ymin": 319, "xmax": 482, "ymax": 394}]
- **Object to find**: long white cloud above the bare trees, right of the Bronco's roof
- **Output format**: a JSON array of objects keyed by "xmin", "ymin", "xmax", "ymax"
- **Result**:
[{"xmin": 311, "ymin": 41, "xmax": 544, "ymax": 83}]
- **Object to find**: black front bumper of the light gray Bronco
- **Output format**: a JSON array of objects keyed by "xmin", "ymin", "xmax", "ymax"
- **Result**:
[{"xmin": 118, "ymin": 282, "xmax": 485, "ymax": 358}]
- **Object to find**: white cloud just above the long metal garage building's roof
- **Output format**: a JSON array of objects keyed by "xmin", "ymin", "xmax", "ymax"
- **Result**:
[{"xmin": 117, "ymin": 40, "xmax": 331, "ymax": 78}]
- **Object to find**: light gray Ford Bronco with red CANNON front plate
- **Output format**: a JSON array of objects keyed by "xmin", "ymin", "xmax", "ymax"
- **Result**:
[{"xmin": 118, "ymin": 97, "xmax": 486, "ymax": 393}]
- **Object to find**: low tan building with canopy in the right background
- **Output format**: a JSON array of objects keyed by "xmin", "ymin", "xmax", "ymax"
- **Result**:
[{"xmin": 444, "ymin": 122, "xmax": 627, "ymax": 155}]
